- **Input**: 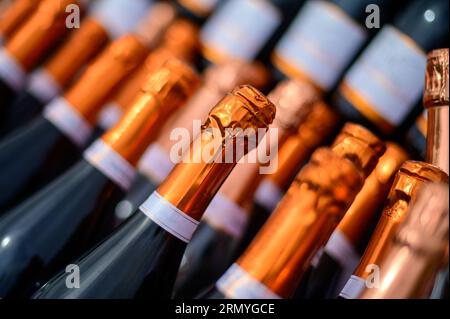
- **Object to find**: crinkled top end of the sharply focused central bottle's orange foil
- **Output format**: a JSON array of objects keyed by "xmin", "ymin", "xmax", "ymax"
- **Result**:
[{"xmin": 231, "ymin": 85, "xmax": 276, "ymax": 127}]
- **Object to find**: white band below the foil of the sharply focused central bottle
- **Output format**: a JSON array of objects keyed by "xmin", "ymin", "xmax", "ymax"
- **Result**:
[{"xmin": 139, "ymin": 191, "xmax": 199, "ymax": 243}]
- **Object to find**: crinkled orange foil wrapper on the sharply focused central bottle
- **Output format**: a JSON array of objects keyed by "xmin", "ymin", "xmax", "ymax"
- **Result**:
[{"xmin": 158, "ymin": 85, "xmax": 275, "ymax": 220}]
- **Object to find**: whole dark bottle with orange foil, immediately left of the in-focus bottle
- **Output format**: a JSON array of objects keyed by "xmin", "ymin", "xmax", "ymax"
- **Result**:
[{"xmin": 0, "ymin": 61, "xmax": 199, "ymax": 297}]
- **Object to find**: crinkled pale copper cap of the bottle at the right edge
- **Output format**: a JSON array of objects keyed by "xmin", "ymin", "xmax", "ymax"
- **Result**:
[{"xmin": 423, "ymin": 48, "xmax": 449, "ymax": 108}]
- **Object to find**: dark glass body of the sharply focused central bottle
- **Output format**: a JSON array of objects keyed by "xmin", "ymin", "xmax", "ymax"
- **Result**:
[{"xmin": 33, "ymin": 211, "xmax": 186, "ymax": 299}]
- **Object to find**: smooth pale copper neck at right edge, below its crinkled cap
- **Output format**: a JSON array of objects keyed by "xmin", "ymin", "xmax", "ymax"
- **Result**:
[{"xmin": 426, "ymin": 105, "xmax": 450, "ymax": 174}]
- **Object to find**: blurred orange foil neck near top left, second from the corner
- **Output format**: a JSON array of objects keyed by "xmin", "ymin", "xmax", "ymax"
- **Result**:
[{"xmin": 5, "ymin": 0, "xmax": 80, "ymax": 71}]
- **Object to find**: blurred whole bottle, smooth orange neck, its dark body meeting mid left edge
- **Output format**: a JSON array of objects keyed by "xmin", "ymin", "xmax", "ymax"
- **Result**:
[{"xmin": 0, "ymin": 36, "xmax": 147, "ymax": 210}]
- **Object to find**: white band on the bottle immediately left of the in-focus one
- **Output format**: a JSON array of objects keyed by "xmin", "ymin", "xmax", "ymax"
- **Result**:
[{"xmin": 83, "ymin": 139, "xmax": 136, "ymax": 191}]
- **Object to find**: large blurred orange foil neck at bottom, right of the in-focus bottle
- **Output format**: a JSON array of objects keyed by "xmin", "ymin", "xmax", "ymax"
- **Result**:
[{"xmin": 232, "ymin": 149, "xmax": 363, "ymax": 298}]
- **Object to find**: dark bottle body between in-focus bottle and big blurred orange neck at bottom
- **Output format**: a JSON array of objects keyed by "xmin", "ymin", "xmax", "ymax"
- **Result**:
[{"xmin": 174, "ymin": 221, "xmax": 238, "ymax": 299}]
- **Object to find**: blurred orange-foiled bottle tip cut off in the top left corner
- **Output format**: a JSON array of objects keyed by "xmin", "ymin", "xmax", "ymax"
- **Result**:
[{"xmin": 0, "ymin": 0, "xmax": 40, "ymax": 45}]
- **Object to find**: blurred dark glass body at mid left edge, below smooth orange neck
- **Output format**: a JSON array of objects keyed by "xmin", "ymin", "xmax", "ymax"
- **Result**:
[{"xmin": 0, "ymin": 116, "xmax": 81, "ymax": 214}]
